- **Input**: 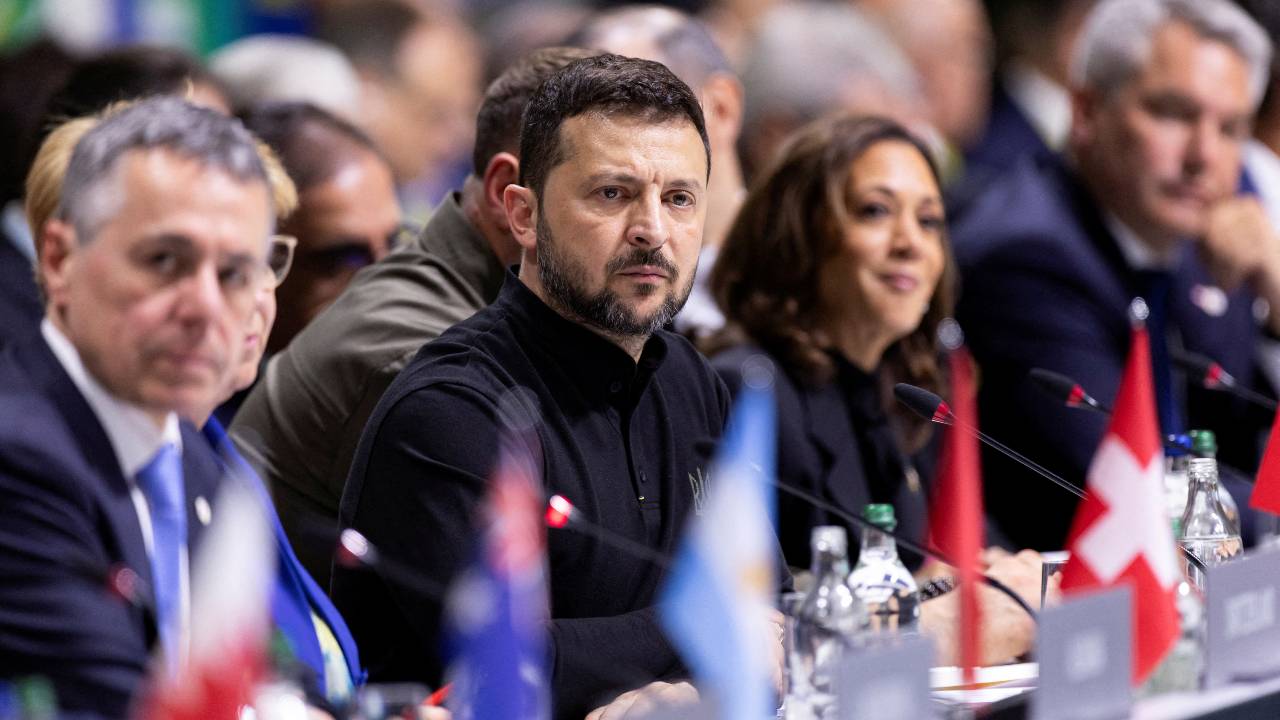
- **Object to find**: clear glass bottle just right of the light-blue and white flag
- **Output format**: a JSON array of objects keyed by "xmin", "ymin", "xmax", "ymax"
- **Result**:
[{"xmin": 787, "ymin": 525, "xmax": 867, "ymax": 717}]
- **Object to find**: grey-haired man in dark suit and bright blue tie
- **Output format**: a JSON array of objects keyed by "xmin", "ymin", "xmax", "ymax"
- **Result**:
[{"xmin": 0, "ymin": 97, "xmax": 275, "ymax": 717}]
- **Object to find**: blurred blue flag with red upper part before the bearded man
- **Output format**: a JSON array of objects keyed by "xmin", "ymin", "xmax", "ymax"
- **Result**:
[{"xmin": 445, "ymin": 443, "xmax": 550, "ymax": 720}]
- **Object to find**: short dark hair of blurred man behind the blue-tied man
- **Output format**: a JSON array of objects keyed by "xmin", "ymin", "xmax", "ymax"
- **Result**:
[{"xmin": 241, "ymin": 101, "xmax": 385, "ymax": 192}]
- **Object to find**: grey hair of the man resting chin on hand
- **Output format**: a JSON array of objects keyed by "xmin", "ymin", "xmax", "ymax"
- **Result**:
[{"xmin": 1071, "ymin": 0, "xmax": 1271, "ymax": 108}]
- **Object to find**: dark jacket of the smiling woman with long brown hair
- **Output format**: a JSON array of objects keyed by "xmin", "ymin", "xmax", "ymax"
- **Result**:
[{"xmin": 712, "ymin": 346, "xmax": 929, "ymax": 569}]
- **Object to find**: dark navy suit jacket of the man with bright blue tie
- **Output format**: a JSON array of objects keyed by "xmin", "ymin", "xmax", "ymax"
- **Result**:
[{"xmin": 0, "ymin": 332, "xmax": 221, "ymax": 717}]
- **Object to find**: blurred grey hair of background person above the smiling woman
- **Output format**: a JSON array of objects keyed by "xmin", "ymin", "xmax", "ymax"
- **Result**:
[{"xmin": 742, "ymin": 1, "xmax": 920, "ymax": 126}]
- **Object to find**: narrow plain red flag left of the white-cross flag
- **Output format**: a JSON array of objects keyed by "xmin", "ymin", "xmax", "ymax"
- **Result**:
[{"xmin": 929, "ymin": 346, "xmax": 983, "ymax": 683}]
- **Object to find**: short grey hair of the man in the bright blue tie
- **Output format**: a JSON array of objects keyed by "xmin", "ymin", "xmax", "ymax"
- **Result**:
[{"xmin": 58, "ymin": 96, "xmax": 270, "ymax": 242}]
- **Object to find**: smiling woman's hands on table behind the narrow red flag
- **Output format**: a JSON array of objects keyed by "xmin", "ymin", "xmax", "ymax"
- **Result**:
[{"xmin": 920, "ymin": 550, "xmax": 1059, "ymax": 665}]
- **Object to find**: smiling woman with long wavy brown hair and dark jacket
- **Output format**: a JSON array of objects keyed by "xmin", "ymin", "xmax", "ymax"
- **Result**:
[{"xmin": 708, "ymin": 117, "xmax": 1041, "ymax": 665}]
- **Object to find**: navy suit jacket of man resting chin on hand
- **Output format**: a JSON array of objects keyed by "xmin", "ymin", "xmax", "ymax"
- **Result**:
[{"xmin": 951, "ymin": 158, "xmax": 1270, "ymax": 550}]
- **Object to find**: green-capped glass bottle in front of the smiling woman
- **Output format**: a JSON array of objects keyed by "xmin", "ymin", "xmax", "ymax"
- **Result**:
[{"xmin": 849, "ymin": 503, "xmax": 920, "ymax": 633}]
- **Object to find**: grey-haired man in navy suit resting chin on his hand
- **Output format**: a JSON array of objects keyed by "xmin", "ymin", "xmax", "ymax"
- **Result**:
[{"xmin": 951, "ymin": 0, "xmax": 1280, "ymax": 550}]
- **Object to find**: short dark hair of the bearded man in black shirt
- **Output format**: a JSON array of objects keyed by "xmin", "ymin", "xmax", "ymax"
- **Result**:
[{"xmin": 520, "ymin": 54, "xmax": 712, "ymax": 202}]
